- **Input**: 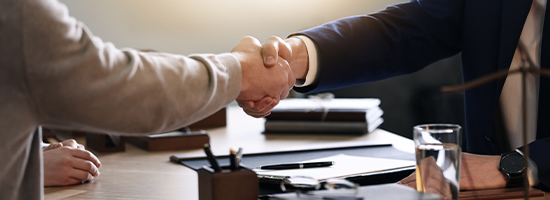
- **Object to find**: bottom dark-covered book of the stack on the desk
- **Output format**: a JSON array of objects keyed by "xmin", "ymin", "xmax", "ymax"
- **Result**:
[{"xmin": 264, "ymin": 117, "xmax": 384, "ymax": 134}]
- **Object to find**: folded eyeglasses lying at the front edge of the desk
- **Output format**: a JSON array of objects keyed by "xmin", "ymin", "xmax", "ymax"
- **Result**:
[{"xmin": 280, "ymin": 176, "xmax": 363, "ymax": 200}]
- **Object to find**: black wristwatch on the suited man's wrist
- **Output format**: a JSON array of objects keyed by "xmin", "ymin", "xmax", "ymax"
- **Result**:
[{"xmin": 499, "ymin": 149, "xmax": 525, "ymax": 187}]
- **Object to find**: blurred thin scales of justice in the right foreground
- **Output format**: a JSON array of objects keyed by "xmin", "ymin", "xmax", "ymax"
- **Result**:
[{"xmin": 441, "ymin": 60, "xmax": 550, "ymax": 199}]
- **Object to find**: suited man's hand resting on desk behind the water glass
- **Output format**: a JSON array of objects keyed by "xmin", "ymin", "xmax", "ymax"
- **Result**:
[{"xmin": 398, "ymin": 153, "xmax": 506, "ymax": 195}]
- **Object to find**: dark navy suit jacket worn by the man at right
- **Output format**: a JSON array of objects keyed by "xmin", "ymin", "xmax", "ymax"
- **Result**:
[{"xmin": 295, "ymin": 0, "xmax": 550, "ymax": 191}]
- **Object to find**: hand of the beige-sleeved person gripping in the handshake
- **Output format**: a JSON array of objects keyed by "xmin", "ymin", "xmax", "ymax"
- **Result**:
[{"xmin": 232, "ymin": 37, "xmax": 296, "ymax": 117}]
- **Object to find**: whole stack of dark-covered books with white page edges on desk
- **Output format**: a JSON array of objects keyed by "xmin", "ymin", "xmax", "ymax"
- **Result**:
[{"xmin": 265, "ymin": 98, "xmax": 384, "ymax": 134}]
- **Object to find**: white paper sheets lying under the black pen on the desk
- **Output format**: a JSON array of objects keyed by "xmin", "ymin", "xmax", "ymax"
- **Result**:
[{"xmin": 254, "ymin": 154, "xmax": 415, "ymax": 181}]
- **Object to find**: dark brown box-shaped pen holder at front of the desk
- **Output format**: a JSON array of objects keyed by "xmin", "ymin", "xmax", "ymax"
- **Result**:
[{"xmin": 197, "ymin": 166, "xmax": 259, "ymax": 200}]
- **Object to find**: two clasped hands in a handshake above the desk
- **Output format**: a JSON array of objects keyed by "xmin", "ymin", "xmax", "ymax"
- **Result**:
[{"xmin": 231, "ymin": 36, "xmax": 308, "ymax": 117}]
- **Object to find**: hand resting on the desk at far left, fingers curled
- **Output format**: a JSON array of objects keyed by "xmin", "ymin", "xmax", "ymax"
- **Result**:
[{"xmin": 44, "ymin": 140, "xmax": 101, "ymax": 186}]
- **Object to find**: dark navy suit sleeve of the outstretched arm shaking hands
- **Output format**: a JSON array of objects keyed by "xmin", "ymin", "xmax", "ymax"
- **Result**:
[{"xmin": 295, "ymin": 0, "xmax": 464, "ymax": 92}]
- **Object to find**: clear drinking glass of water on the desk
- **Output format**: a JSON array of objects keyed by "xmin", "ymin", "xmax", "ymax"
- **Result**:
[{"xmin": 414, "ymin": 124, "xmax": 462, "ymax": 199}]
